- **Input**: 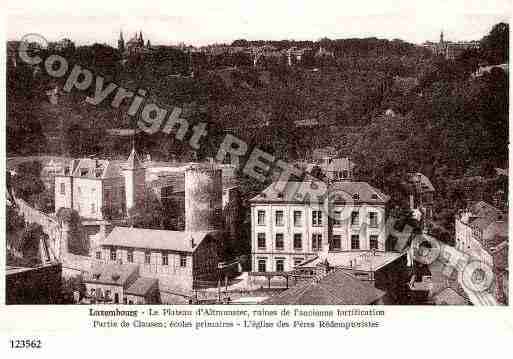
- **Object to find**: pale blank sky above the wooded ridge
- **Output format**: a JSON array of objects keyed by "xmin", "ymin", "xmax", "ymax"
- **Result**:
[{"xmin": 7, "ymin": 0, "xmax": 512, "ymax": 46}]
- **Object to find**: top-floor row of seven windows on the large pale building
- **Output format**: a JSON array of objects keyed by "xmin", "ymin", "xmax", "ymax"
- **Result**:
[{"xmin": 257, "ymin": 210, "xmax": 378, "ymax": 228}]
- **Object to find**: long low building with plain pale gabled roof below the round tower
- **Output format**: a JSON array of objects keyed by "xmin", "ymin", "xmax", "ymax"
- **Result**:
[{"xmin": 95, "ymin": 227, "xmax": 223, "ymax": 296}]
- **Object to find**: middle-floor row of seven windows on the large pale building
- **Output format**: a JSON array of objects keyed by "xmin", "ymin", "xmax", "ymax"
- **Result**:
[{"xmin": 257, "ymin": 233, "xmax": 378, "ymax": 251}]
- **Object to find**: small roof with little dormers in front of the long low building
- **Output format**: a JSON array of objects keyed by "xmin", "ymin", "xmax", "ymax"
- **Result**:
[{"xmin": 84, "ymin": 263, "xmax": 139, "ymax": 287}]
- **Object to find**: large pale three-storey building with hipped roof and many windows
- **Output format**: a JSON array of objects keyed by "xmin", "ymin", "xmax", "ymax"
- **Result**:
[{"xmin": 251, "ymin": 181, "xmax": 389, "ymax": 272}]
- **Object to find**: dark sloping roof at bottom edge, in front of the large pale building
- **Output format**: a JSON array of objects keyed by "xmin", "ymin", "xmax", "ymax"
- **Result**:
[{"xmin": 262, "ymin": 270, "xmax": 385, "ymax": 305}]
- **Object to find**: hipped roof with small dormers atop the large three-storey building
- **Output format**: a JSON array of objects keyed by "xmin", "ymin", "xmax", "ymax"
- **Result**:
[{"xmin": 251, "ymin": 181, "xmax": 390, "ymax": 204}]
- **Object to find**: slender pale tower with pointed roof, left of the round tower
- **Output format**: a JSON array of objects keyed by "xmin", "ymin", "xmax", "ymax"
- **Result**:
[{"xmin": 122, "ymin": 147, "xmax": 146, "ymax": 213}]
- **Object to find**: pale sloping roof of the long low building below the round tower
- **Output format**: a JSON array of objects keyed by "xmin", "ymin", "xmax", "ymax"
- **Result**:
[{"xmin": 102, "ymin": 227, "xmax": 215, "ymax": 253}]
